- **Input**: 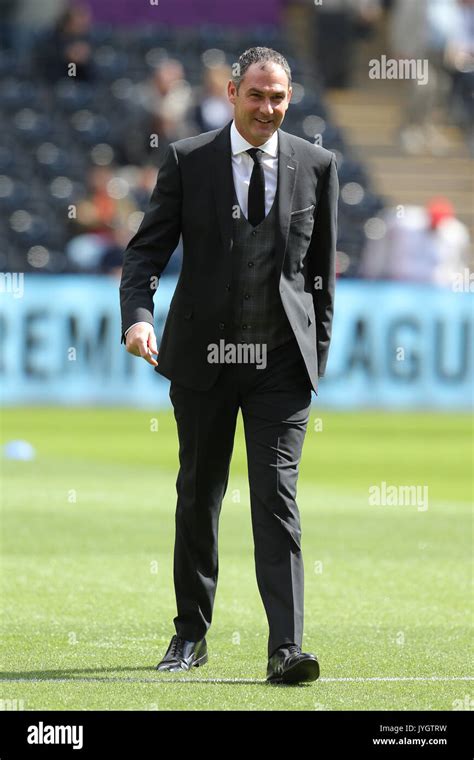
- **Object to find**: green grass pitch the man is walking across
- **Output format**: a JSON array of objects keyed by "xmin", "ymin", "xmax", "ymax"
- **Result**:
[{"xmin": 0, "ymin": 407, "xmax": 474, "ymax": 710}]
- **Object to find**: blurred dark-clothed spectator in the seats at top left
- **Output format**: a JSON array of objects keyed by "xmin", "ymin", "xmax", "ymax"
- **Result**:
[{"xmin": 36, "ymin": 5, "xmax": 95, "ymax": 83}]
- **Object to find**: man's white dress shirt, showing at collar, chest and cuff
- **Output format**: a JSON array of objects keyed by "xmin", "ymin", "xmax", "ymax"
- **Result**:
[{"xmin": 125, "ymin": 120, "xmax": 278, "ymax": 335}]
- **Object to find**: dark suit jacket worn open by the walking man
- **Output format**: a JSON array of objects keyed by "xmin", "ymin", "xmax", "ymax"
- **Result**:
[{"xmin": 120, "ymin": 121, "xmax": 339, "ymax": 393}]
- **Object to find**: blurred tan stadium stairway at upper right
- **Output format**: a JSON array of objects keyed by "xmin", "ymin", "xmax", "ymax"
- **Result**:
[{"xmin": 325, "ymin": 56, "xmax": 474, "ymax": 255}]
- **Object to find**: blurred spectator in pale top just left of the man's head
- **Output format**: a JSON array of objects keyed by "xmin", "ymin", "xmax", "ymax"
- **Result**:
[{"xmin": 194, "ymin": 65, "xmax": 234, "ymax": 132}]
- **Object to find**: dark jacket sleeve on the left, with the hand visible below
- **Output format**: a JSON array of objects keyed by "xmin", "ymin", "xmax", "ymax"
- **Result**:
[{"xmin": 119, "ymin": 143, "xmax": 182, "ymax": 343}]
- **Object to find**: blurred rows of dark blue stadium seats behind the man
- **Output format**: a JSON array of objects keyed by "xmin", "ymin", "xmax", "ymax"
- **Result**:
[{"xmin": 0, "ymin": 25, "xmax": 383, "ymax": 276}]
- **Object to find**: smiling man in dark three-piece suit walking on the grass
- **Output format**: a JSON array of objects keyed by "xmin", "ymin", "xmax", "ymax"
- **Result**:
[{"xmin": 120, "ymin": 47, "xmax": 339, "ymax": 682}]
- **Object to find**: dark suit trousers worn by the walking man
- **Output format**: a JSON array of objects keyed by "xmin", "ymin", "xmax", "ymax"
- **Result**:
[{"xmin": 170, "ymin": 338, "xmax": 311, "ymax": 656}]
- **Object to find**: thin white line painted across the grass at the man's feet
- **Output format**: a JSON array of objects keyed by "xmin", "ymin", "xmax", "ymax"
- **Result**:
[{"xmin": 0, "ymin": 676, "xmax": 474, "ymax": 684}]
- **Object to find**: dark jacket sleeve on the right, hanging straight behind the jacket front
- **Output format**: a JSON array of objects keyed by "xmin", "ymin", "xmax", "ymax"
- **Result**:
[{"xmin": 310, "ymin": 154, "xmax": 339, "ymax": 377}]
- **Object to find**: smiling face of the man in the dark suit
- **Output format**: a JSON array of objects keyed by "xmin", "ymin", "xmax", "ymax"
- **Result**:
[{"xmin": 227, "ymin": 62, "xmax": 292, "ymax": 147}]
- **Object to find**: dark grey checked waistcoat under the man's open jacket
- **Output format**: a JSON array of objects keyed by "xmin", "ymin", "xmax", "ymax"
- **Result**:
[{"xmin": 228, "ymin": 178, "xmax": 294, "ymax": 351}]
